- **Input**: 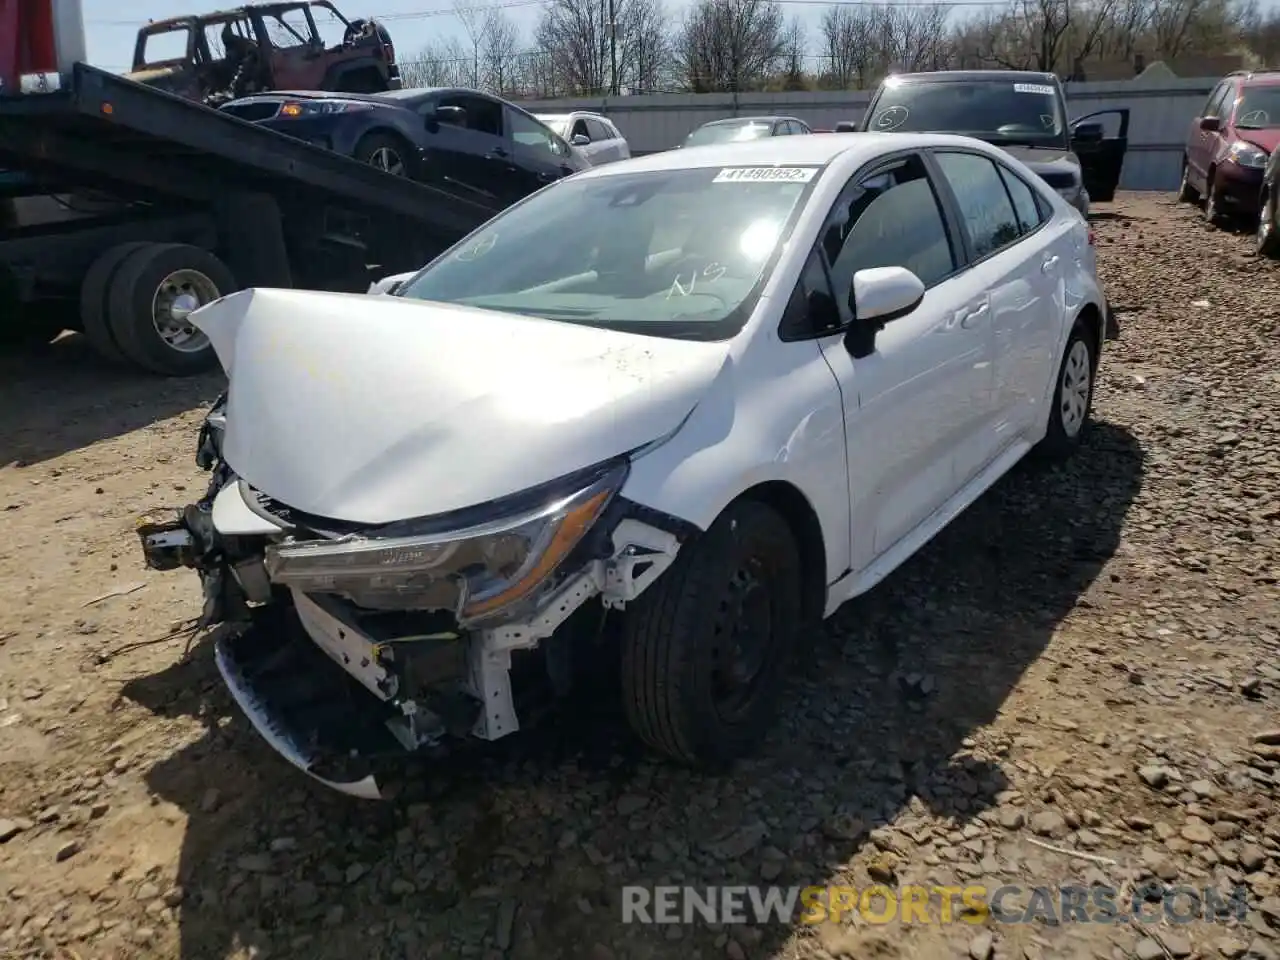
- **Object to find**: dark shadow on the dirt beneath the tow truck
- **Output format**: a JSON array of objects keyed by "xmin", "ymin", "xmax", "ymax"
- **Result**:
[{"xmin": 0, "ymin": 333, "xmax": 224, "ymax": 467}]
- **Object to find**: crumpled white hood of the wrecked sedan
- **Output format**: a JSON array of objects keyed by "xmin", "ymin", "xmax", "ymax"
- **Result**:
[{"xmin": 192, "ymin": 289, "xmax": 728, "ymax": 525}]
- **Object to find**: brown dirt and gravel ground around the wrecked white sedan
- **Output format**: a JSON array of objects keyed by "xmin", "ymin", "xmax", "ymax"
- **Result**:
[{"xmin": 0, "ymin": 195, "xmax": 1280, "ymax": 960}]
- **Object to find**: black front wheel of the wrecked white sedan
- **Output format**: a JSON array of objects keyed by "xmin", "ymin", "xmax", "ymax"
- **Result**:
[{"xmin": 622, "ymin": 500, "xmax": 803, "ymax": 764}]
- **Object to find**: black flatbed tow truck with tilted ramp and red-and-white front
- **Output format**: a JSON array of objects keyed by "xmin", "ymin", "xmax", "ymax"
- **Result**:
[{"xmin": 0, "ymin": 0, "xmax": 492, "ymax": 376}]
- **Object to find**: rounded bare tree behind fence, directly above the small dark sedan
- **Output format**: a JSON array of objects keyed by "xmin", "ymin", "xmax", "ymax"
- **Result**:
[{"xmin": 675, "ymin": 0, "xmax": 786, "ymax": 93}]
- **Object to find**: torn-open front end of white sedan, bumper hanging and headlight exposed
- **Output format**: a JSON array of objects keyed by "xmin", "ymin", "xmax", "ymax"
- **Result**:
[{"xmin": 138, "ymin": 394, "xmax": 689, "ymax": 799}]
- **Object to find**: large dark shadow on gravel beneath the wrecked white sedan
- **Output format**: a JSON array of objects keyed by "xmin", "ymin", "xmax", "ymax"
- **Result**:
[{"xmin": 125, "ymin": 422, "xmax": 1143, "ymax": 960}]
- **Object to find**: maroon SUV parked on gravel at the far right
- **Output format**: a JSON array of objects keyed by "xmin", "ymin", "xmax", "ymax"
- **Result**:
[{"xmin": 1178, "ymin": 70, "xmax": 1280, "ymax": 223}]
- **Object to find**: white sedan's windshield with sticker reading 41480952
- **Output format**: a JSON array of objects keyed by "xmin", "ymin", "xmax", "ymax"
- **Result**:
[{"xmin": 397, "ymin": 166, "xmax": 819, "ymax": 340}]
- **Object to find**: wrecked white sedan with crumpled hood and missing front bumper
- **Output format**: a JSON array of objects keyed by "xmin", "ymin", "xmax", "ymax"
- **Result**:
[{"xmin": 140, "ymin": 133, "xmax": 1112, "ymax": 797}]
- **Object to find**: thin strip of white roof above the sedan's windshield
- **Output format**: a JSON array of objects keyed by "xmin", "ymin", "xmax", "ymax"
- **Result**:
[{"xmin": 573, "ymin": 133, "xmax": 995, "ymax": 179}]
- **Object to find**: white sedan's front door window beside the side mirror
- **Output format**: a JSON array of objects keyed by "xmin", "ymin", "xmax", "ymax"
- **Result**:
[{"xmin": 820, "ymin": 156, "xmax": 956, "ymax": 298}]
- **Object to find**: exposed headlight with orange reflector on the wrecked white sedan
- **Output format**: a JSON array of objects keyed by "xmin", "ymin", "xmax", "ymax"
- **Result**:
[{"xmin": 266, "ymin": 461, "xmax": 627, "ymax": 623}]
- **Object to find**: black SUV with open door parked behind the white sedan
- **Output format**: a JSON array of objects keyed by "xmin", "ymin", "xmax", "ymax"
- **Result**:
[{"xmin": 860, "ymin": 70, "xmax": 1129, "ymax": 216}]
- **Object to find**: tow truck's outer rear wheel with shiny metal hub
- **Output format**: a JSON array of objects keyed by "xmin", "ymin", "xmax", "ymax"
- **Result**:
[{"xmin": 108, "ymin": 243, "xmax": 236, "ymax": 376}]
